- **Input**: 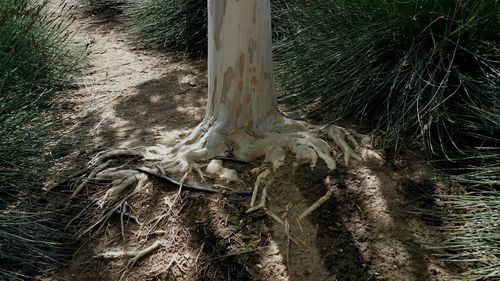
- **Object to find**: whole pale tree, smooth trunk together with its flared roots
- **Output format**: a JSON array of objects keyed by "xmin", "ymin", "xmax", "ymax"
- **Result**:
[{"xmin": 79, "ymin": 0, "xmax": 368, "ymax": 206}]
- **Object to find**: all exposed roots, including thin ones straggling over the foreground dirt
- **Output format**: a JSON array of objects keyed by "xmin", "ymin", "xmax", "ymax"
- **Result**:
[{"xmin": 72, "ymin": 112, "xmax": 386, "ymax": 278}]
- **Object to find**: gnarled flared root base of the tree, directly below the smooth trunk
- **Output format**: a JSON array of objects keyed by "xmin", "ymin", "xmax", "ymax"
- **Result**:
[{"xmin": 73, "ymin": 111, "xmax": 380, "ymax": 210}]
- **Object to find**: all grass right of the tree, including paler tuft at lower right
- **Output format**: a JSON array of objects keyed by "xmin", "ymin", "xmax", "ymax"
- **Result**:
[{"xmin": 275, "ymin": 0, "xmax": 500, "ymax": 280}]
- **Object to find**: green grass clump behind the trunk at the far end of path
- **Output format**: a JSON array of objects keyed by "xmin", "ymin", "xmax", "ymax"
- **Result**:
[{"xmin": 124, "ymin": 0, "xmax": 297, "ymax": 57}]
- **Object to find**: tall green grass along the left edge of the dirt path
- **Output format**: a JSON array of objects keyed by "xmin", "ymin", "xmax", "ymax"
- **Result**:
[{"xmin": 0, "ymin": 0, "xmax": 81, "ymax": 280}]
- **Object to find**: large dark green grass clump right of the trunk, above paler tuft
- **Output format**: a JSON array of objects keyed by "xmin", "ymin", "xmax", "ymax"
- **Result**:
[{"xmin": 275, "ymin": 0, "xmax": 500, "ymax": 153}]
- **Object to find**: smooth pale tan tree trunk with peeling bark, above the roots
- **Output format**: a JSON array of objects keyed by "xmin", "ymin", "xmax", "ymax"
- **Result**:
[{"xmin": 206, "ymin": 0, "xmax": 277, "ymax": 133}]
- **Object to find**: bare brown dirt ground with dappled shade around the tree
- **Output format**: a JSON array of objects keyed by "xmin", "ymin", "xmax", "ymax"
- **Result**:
[{"xmin": 45, "ymin": 2, "xmax": 458, "ymax": 281}]
